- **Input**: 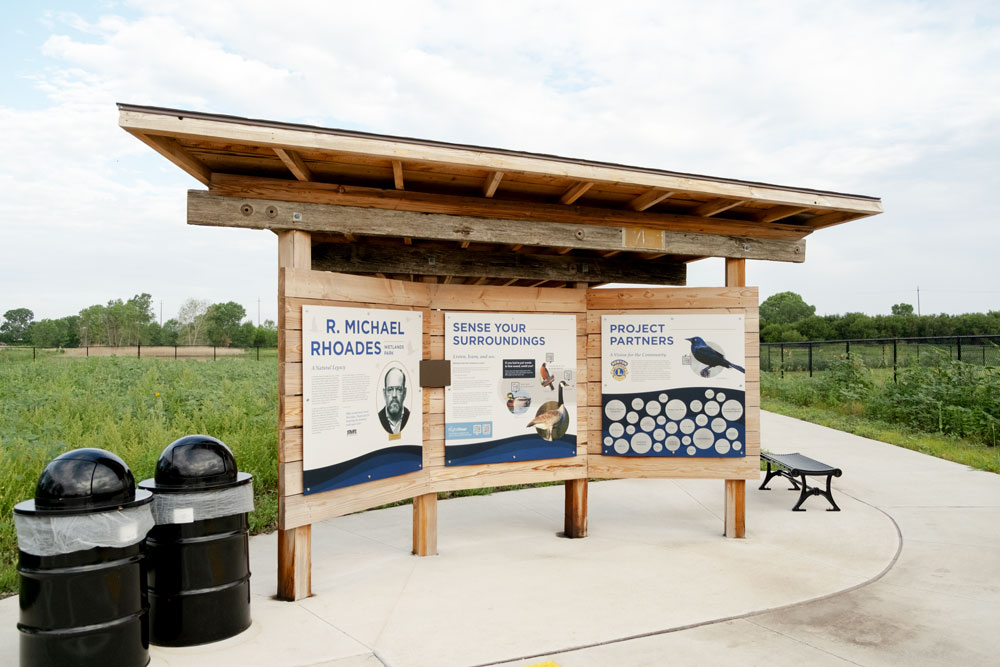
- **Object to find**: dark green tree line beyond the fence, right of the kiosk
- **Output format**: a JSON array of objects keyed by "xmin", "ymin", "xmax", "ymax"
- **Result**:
[{"xmin": 760, "ymin": 292, "xmax": 1000, "ymax": 343}]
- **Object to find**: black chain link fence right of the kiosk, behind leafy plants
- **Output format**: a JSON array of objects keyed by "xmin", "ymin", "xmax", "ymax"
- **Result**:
[{"xmin": 760, "ymin": 334, "xmax": 1000, "ymax": 375}]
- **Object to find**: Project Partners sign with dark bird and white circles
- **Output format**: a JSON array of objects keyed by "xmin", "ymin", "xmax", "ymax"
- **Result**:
[{"xmin": 601, "ymin": 313, "xmax": 746, "ymax": 458}]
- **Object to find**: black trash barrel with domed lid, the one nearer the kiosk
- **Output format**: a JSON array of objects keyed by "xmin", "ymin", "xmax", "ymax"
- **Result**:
[{"xmin": 139, "ymin": 435, "xmax": 253, "ymax": 646}]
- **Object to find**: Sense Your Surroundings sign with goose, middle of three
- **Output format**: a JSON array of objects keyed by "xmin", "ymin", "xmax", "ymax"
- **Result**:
[{"xmin": 445, "ymin": 313, "xmax": 577, "ymax": 466}]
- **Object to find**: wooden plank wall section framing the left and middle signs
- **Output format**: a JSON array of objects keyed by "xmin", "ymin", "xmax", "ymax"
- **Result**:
[{"xmin": 278, "ymin": 268, "xmax": 589, "ymax": 530}]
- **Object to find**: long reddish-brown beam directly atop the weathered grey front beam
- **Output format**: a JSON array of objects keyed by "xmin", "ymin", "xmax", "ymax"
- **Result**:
[{"xmin": 211, "ymin": 174, "xmax": 810, "ymax": 243}]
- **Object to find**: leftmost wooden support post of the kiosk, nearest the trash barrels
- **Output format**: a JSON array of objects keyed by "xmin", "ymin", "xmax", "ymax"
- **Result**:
[{"xmin": 278, "ymin": 230, "xmax": 312, "ymax": 600}]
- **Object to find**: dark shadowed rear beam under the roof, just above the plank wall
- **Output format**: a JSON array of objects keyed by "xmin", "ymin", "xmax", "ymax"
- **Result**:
[{"xmin": 312, "ymin": 243, "xmax": 686, "ymax": 285}]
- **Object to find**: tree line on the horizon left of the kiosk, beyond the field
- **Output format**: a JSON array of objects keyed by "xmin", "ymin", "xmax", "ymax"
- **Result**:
[{"xmin": 0, "ymin": 293, "xmax": 278, "ymax": 347}]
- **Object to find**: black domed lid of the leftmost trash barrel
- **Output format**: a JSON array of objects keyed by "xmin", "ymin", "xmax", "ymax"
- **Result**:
[{"xmin": 14, "ymin": 448, "xmax": 153, "ymax": 516}]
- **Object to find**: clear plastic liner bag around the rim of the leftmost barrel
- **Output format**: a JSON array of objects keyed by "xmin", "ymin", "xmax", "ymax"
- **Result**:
[{"xmin": 14, "ymin": 503, "xmax": 154, "ymax": 556}]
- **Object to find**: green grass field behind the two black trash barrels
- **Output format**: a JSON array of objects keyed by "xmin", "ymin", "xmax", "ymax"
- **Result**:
[{"xmin": 0, "ymin": 358, "xmax": 278, "ymax": 595}]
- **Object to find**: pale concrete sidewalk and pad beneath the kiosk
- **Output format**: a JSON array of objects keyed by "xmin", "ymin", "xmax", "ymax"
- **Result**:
[{"xmin": 0, "ymin": 413, "xmax": 1000, "ymax": 667}]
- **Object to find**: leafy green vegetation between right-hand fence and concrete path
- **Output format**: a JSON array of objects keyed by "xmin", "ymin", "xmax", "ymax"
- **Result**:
[{"xmin": 761, "ymin": 355, "xmax": 1000, "ymax": 472}]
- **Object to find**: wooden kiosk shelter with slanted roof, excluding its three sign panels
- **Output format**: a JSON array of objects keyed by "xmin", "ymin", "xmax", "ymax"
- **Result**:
[{"xmin": 119, "ymin": 104, "xmax": 882, "ymax": 599}]
